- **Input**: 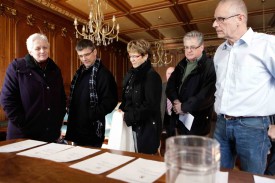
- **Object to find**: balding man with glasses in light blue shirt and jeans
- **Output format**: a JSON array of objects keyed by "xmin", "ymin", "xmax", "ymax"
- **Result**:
[{"xmin": 213, "ymin": 0, "xmax": 275, "ymax": 174}]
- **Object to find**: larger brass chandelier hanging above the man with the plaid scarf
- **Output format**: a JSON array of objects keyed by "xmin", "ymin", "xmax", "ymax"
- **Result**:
[{"xmin": 74, "ymin": 0, "xmax": 119, "ymax": 46}]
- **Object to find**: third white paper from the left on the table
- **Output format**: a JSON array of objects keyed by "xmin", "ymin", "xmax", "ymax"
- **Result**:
[{"xmin": 44, "ymin": 146, "xmax": 100, "ymax": 162}]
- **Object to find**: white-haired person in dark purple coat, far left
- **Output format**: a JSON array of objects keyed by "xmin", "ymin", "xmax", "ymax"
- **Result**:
[{"xmin": 1, "ymin": 33, "xmax": 66, "ymax": 142}]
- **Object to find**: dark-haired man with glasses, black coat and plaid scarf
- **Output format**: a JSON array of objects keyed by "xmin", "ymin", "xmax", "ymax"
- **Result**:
[{"xmin": 65, "ymin": 39, "xmax": 118, "ymax": 147}]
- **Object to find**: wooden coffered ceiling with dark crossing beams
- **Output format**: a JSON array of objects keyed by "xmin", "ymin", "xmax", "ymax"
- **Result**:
[{"xmin": 27, "ymin": 0, "xmax": 275, "ymax": 49}]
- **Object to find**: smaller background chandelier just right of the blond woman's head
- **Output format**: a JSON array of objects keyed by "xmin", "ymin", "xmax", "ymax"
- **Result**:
[{"xmin": 152, "ymin": 41, "xmax": 173, "ymax": 67}]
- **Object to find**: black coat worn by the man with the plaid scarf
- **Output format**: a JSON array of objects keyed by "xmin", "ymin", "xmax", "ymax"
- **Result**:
[{"xmin": 66, "ymin": 61, "xmax": 118, "ymax": 147}]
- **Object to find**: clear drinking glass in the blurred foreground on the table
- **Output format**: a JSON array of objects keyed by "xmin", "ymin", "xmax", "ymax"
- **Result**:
[{"xmin": 164, "ymin": 135, "xmax": 220, "ymax": 183}]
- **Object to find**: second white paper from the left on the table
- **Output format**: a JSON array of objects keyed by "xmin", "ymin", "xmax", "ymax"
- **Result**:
[{"xmin": 17, "ymin": 143, "xmax": 74, "ymax": 159}]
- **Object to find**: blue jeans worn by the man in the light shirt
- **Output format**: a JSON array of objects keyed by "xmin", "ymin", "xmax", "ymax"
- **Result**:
[{"xmin": 214, "ymin": 115, "xmax": 271, "ymax": 174}]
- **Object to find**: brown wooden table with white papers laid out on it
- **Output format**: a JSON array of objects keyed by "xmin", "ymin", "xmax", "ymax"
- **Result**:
[{"xmin": 0, "ymin": 139, "xmax": 275, "ymax": 183}]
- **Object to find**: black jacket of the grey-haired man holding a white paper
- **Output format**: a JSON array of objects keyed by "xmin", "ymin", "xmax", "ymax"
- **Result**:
[{"xmin": 166, "ymin": 52, "xmax": 216, "ymax": 135}]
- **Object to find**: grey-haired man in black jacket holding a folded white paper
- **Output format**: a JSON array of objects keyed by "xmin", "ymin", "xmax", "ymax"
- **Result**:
[{"xmin": 166, "ymin": 31, "xmax": 216, "ymax": 135}]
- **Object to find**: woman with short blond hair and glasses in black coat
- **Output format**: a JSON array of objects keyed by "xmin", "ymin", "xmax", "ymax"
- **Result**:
[{"xmin": 119, "ymin": 40, "xmax": 162, "ymax": 154}]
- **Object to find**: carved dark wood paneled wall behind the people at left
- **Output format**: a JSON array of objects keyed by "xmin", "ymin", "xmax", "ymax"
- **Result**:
[{"xmin": 0, "ymin": 0, "xmax": 129, "ymax": 121}]
